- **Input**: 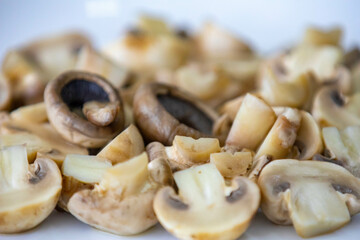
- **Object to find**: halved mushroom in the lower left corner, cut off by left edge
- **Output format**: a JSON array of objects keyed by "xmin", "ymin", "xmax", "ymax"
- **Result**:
[{"xmin": 0, "ymin": 146, "xmax": 61, "ymax": 233}]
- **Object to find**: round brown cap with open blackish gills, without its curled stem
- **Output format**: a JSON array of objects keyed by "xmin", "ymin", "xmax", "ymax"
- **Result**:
[{"xmin": 44, "ymin": 71, "xmax": 125, "ymax": 148}]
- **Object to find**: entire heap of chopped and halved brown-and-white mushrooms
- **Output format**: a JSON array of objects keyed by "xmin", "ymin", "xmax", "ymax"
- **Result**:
[{"xmin": 0, "ymin": 17, "xmax": 360, "ymax": 239}]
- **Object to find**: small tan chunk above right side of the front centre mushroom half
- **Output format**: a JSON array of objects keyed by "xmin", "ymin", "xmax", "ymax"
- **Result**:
[{"xmin": 210, "ymin": 152, "xmax": 253, "ymax": 178}]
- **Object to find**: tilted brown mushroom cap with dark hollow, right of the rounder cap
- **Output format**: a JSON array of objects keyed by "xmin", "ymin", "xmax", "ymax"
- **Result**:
[{"xmin": 134, "ymin": 83, "xmax": 218, "ymax": 145}]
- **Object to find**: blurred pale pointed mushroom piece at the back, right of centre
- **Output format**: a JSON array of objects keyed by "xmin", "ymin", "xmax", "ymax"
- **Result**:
[{"xmin": 195, "ymin": 23, "xmax": 252, "ymax": 61}]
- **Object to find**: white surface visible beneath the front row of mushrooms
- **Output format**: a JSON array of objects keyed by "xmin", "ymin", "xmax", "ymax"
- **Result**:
[{"xmin": 0, "ymin": 211, "xmax": 360, "ymax": 240}]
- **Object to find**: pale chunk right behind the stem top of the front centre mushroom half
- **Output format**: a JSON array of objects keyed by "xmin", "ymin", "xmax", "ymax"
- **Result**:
[{"xmin": 166, "ymin": 136, "xmax": 221, "ymax": 169}]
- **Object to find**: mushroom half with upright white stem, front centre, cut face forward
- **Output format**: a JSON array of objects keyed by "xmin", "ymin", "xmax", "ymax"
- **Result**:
[{"xmin": 154, "ymin": 163, "xmax": 260, "ymax": 239}]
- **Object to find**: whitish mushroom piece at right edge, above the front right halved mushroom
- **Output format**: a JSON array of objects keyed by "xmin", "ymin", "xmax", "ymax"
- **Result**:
[{"xmin": 322, "ymin": 126, "xmax": 360, "ymax": 178}]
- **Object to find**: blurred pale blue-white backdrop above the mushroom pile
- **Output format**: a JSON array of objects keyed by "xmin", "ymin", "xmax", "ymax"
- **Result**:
[{"xmin": 0, "ymin": 0, "xmax": 360, "ymax": 61}]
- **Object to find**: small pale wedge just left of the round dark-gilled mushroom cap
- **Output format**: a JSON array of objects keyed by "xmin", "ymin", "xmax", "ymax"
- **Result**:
[{"xmin": 10, "ymin": 102, "xmax": 48, "ymax": 123}]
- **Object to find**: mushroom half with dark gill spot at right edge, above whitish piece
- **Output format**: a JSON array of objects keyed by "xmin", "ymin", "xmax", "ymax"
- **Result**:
[{"xmin": 312, "ymin": 86, "xmax": 360, "ymax": 129}]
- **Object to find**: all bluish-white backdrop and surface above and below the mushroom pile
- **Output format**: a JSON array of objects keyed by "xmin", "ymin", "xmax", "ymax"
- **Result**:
[{"xmin": 0, "ymin": 0, "xmax": 360, "ymax": 240}]
